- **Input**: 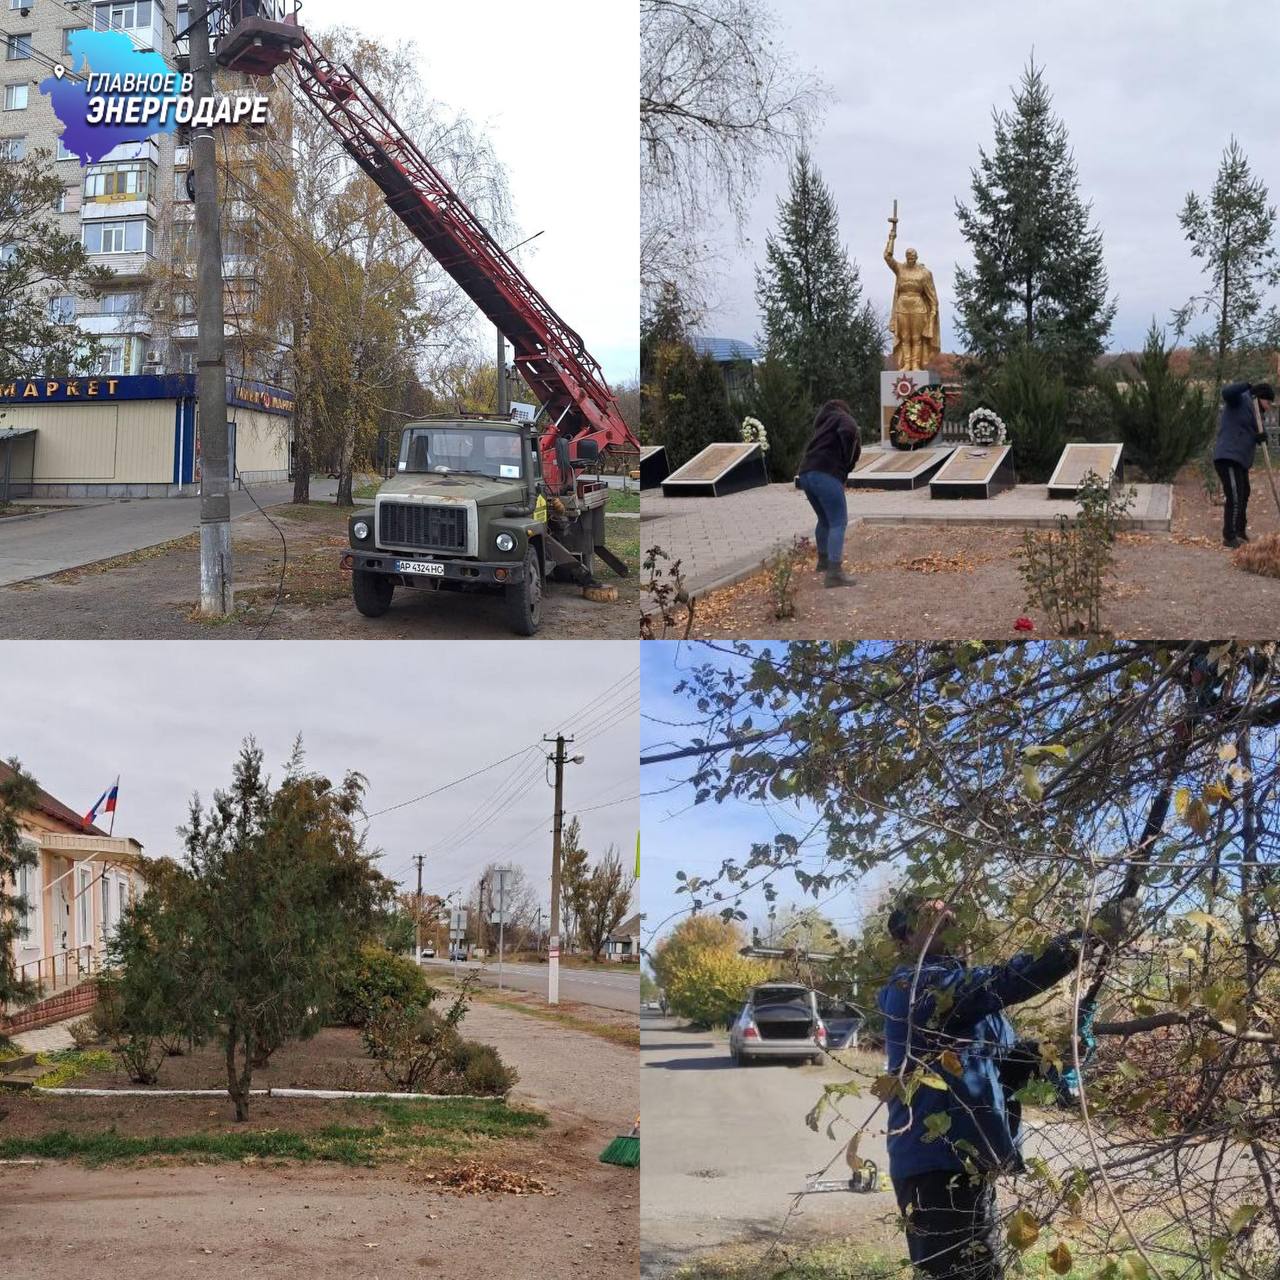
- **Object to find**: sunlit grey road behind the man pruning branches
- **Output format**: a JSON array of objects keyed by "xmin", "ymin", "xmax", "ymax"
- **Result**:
[{"xmin": 640, "ymin": 1012, "xmax": 896, "ymax": 1280}]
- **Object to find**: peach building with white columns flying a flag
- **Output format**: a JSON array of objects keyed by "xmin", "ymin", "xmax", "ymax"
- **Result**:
[{"xmin": 0, "ymin": 763, "xmax": 143, "ymax": 1032}]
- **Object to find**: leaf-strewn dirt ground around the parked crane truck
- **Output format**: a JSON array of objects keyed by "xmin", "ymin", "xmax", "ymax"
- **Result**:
[{"xmin": 0, "ymin": 503, "xmax": 640, "ymax": 640}]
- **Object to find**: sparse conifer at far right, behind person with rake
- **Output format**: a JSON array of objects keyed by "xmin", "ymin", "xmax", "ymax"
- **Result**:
[{"xmin": 1175, "ymin": 138, "xmax": 1280, "ymax": 386}]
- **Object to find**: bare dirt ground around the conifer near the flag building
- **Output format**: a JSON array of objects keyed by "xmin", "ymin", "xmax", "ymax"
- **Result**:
[{"xmin": 0, "ymin": 1002, "xmax": 639, "ymax": 1280}]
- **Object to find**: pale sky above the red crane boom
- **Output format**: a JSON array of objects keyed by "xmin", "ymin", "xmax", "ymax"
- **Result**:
[{"xmin": 302, "ymin": 0, "xmax": 640, "ymax": 383}]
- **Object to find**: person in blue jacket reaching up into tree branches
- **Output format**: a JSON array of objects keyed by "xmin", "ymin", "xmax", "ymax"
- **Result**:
[{"xmin": 878, "ymin": 896, "xmax": 1137, "ymax": 1280}]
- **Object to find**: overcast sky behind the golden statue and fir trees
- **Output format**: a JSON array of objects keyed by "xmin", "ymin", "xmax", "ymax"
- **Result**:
[{"xmin": 704, "ymin": 0, "xmax": 1280, "ymax": 351}]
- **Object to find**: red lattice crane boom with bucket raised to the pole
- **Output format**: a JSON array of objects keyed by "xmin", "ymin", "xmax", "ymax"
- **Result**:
[{"xmin": 218, "ymin": 0, "xmax": 640, "ymax": 484}]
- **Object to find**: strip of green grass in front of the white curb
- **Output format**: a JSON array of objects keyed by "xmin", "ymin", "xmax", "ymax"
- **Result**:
[{"xmin": 0, "ymin": 1098, "xmax": 548, "ymax": 1165}]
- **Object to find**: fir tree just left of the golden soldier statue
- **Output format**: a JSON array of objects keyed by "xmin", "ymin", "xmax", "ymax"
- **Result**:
[{"xmin": 755, "ymin": 147, "xmax": 883, "ymax": 428}]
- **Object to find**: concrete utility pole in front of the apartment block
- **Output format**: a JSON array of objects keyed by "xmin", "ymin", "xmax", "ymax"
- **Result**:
[{"xmin": 189, "ymin": 0, "xmax": 236, "ymax": 617}]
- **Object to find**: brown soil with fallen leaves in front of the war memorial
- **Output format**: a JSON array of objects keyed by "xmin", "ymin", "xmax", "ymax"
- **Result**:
[{"xmin": 668, "ymin": 467, "xmax": 1280, "ymax": 640}]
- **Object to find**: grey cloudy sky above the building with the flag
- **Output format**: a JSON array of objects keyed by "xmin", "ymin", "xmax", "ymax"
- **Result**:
[{"xmin": 0, "ymin": 640, "xmax": 639, "ymax": 902}]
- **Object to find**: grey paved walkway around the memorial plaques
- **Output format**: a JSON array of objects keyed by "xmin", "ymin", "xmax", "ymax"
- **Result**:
[{"xmin": 640, "ymin": 484, "xmax": 1174, "ymax": 593}]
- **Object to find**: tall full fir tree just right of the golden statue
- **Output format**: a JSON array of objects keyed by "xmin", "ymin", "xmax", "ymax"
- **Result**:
[{"xmin": 956, "ymin": 60, "xmax": 1116, "ymax": 387}]
